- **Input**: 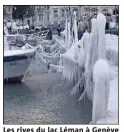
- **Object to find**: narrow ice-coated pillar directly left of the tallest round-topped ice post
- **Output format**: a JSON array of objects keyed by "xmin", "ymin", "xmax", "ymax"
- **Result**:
[{"xmin": 79, "ymin": 18, "xmax": 98, "ymax": 101}]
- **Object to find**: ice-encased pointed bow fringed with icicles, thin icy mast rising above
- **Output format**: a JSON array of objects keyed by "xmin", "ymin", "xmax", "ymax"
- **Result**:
[{"xmin": 60, "ymin": 12, "xmax": 80, "ymax": 82}]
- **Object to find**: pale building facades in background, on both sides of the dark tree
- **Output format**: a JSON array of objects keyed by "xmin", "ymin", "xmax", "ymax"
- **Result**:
[{"xmin": 4, "ymin": 5, "xmax": 116, "ymax": 26}]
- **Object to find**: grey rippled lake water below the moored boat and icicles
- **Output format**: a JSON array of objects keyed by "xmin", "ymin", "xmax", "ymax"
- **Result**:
[{"xmin": 4, "ymin": 62, "xmax": 92, "ymax": 125}]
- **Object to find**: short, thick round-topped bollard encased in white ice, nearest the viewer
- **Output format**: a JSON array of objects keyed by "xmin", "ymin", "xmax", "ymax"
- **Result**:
[{"xmin": 92, "ymin": 60, "xmax": 110, "ymax": 124}]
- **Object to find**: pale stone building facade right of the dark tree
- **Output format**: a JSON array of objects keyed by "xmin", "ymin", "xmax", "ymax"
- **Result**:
[{"xmin": 36, "ymin": 6, "xmax": 115, "ymax": 25}]
